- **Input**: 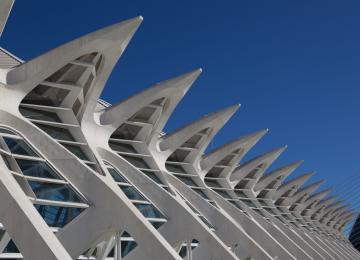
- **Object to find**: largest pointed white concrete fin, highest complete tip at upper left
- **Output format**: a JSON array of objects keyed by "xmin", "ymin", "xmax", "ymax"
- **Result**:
[{"xmin": 1, "ymin": 16, "xmax": 143, "ymax": 85}]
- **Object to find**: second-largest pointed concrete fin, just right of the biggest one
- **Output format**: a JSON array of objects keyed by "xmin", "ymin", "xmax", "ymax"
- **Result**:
[{"xmin": 100, "ymin": 69, "xmax": 202, "ymax": 132}]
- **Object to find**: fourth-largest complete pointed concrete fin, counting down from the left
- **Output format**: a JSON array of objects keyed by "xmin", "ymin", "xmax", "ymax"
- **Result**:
[{"xmin": 200, "ymin": 129, "xmax": 268, "ymax": 171}]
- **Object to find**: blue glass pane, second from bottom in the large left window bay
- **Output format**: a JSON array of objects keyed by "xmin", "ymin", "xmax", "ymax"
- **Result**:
[{"xmin": 29, "ymin": 181, "xmax": 82, "ymax": 202}]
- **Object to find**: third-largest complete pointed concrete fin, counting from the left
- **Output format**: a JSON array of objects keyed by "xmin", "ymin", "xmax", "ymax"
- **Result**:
[{"xmin": 159, "ymin": 105, "xmax": 240, "ymax": 152}]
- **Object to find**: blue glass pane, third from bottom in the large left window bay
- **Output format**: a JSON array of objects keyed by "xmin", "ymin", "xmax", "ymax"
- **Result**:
[{"xmin": 16, "ymin": 159, "xmax": 60, "ymax": 179}]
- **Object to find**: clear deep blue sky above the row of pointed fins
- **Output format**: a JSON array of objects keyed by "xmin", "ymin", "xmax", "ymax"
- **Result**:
[{"xmin": 1, "ymin": 0, "xmax": 360, "ymax": 209}]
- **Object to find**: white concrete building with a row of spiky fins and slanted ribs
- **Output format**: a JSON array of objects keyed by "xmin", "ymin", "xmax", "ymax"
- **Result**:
[{"xmin": 0, "ymin": 0, "xmax": 360, "ymax": 260}]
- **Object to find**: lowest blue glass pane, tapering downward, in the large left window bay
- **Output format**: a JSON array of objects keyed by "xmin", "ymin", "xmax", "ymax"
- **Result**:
[{"xmin": 34, "ymin": 204, "xmax": 84, "ymax": 227}]
